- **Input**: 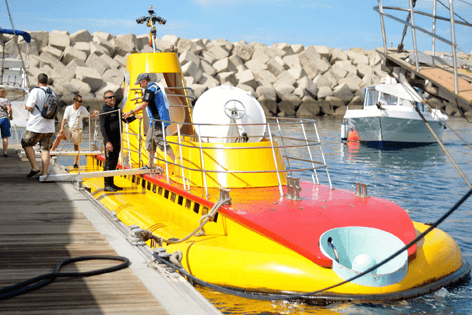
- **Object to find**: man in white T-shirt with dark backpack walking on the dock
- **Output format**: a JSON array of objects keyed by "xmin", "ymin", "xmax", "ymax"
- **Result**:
[{"xmin": 21, "ymin": 73, "xmax": 57, "ymax": 178}]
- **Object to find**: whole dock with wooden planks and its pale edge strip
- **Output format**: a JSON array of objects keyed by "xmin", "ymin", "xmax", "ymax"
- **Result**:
[{"xmin": 0, "ymin": 148, "xmax": 221, "ymax": 315}]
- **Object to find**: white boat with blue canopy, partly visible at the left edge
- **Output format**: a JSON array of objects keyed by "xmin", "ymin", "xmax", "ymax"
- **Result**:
[{"xmin": 0, "ymin": 29, "xmax": 31, "ymax": 144}]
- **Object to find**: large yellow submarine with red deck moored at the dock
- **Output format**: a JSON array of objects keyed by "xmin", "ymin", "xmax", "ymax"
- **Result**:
[{"xmin": 76, "ymin": 6, "xmax": 471, "ymax": 301}]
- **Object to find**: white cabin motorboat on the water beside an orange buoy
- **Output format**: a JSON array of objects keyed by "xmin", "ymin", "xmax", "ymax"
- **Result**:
[{"xmin": 341, "ymin": 78, "xmax": 449, "ymax": 144}]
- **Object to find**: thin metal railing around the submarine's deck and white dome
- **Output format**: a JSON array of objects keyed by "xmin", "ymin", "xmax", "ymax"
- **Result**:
[{"xmin": 118, "ymin": 112, "xmax": 333, "ymax": 198}]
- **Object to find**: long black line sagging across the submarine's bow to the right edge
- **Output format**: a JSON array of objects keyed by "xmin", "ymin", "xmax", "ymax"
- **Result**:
[{"xmin": 156, "ymin": 189, "xmax": 472, "ymax": 301}]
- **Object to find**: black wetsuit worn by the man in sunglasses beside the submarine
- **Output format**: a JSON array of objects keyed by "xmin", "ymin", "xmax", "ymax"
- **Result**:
[{"xmin": 100, "ymin": 104, "xmax": 136, "ymax": 186}]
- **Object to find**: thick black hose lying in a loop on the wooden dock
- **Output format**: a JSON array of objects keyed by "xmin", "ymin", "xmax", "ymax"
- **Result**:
[{"xmin": 0, "ymin": 256, "xmax": 130, "ymax": 301}]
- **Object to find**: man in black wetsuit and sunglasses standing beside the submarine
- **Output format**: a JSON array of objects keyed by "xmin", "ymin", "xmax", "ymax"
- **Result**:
[{"xmin": 100, "ymin": 91, "xmax": 136, "ymax": 191}]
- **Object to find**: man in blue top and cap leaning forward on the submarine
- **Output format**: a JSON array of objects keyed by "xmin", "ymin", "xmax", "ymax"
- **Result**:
[{"xmin": 123, "ymin": 73, "xmax": 175, "ymax": 168}]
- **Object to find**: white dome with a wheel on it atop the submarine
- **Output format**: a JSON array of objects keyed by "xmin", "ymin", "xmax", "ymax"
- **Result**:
[{"xmin": 193, "ymin": 85, "xmax": 266, "ymax": 143}]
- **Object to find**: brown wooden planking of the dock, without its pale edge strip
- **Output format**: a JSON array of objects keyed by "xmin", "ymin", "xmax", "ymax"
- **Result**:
[{"xmin": 0, "ymin": 152, "xmax": 168, "ymax": 315}]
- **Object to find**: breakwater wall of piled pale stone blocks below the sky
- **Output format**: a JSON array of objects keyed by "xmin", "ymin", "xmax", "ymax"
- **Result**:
[{"xmin": 0, "ymin": 30, "xmax": 470, "ymax": 119}]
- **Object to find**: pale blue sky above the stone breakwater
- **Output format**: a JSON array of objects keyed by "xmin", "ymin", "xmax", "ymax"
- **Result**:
[{"xmin": 0, "ymin": 0, "xmax": 472, "ymax": 53}]
